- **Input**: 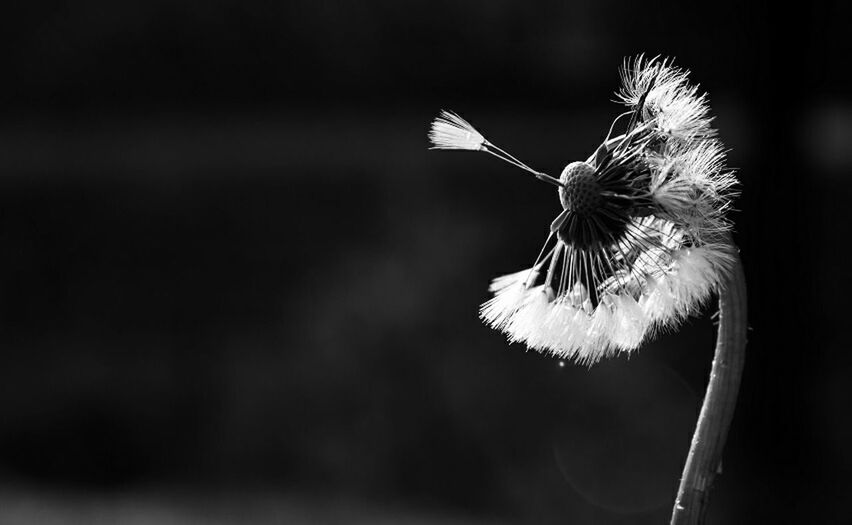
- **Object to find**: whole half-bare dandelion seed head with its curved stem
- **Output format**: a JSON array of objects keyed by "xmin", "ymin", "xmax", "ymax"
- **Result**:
[{"xmin": 429, "ymin": 56, "xmax": 745, "ymax": 524}]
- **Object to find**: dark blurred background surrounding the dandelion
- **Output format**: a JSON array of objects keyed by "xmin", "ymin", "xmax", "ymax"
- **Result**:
[{"xmin": 0, "ymin": 0, "xmax": 852, "ymax": 524}]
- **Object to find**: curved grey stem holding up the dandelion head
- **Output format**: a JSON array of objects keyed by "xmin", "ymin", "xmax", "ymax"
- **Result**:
[{"xmin": 671, "ymin": 248, "xmax": 748, "ymax": 525}]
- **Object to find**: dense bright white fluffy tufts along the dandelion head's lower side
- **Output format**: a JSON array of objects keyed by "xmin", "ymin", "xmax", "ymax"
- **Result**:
[{"xmin": 480, "ymin": 220, "xmax": 733, "ymax": 364}]
